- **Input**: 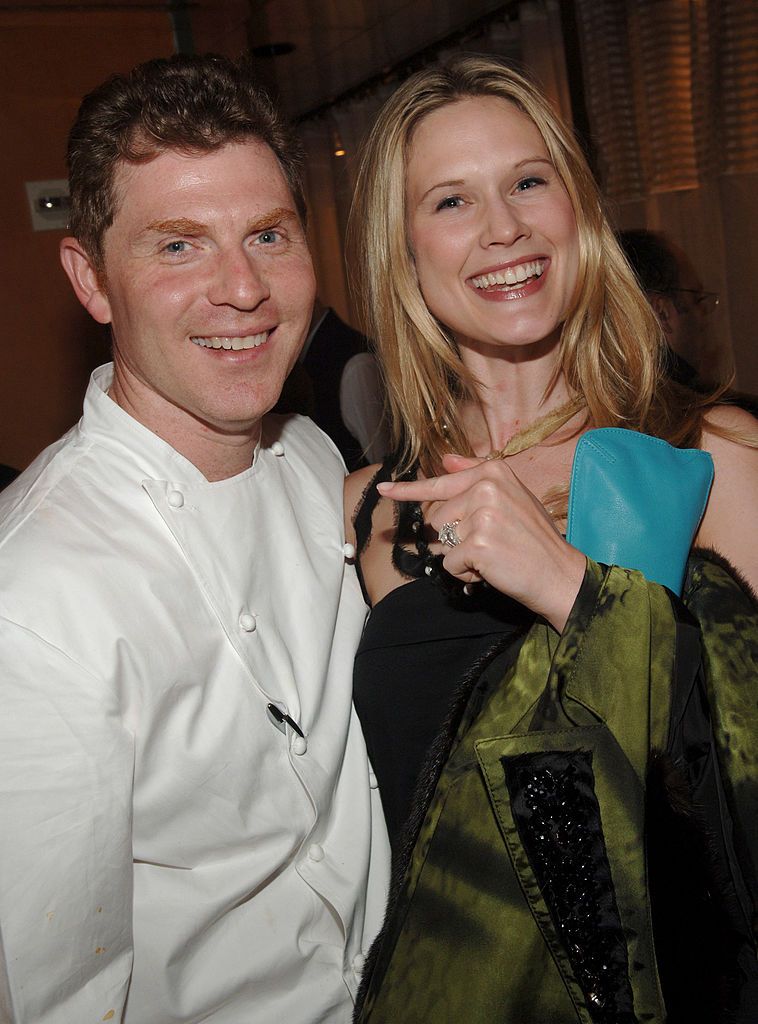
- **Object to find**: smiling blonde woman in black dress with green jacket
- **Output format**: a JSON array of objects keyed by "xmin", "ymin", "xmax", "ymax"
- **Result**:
[{"xmin": 346, "ymin": 57, "xmax": 758, "ymax": 1024}]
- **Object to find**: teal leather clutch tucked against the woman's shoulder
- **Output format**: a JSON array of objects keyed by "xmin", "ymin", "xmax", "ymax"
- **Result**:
[{"xmin": 566, "ymin": 427, "xmax": 713, "ymax": 594}]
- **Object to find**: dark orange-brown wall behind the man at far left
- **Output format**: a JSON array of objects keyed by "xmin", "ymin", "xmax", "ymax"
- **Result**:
[{"xmin": 0, "ymin": 5, "xmax": 174, "ymax": 469}]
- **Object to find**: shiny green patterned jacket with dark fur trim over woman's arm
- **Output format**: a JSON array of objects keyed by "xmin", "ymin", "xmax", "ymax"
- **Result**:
[{"xmin": 355, "ymin": 553, "xmax": 758, "ymax": 1024}]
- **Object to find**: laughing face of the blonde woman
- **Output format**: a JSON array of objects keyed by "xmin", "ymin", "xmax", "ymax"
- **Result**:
[{"xmin": 406, "ymin": 96, "xmax": 579, "ymax": 357}]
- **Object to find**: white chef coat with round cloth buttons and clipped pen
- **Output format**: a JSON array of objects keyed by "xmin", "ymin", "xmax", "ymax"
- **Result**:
[{"xmin": 0, "ymin": 367, "xmax": 388, "ymax": 1024}]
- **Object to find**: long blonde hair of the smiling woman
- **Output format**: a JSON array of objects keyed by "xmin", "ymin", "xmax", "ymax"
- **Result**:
[{"xmin": 348, "ymin": 55, "xmax": 706, "ymax": 474}]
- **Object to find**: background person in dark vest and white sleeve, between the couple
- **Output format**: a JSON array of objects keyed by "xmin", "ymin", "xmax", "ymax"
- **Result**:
[{"xmin": 275, "ymin": 299, "xmax": 388, "ymax": 471}]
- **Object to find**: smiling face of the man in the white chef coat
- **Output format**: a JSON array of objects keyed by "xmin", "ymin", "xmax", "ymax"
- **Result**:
[{"xmin": 65, "ymin": 140, "xmax": 315, "ymax": 451}]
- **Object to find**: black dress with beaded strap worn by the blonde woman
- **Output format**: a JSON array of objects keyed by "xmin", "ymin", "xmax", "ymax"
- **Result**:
[{"xmin": 353, "ymin": 461, "xmax": 534, "ymax": 851}]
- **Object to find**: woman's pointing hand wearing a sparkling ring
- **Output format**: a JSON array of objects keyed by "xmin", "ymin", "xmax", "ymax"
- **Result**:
[{"xmin": 378, "ymin": 455, "xmax": 586, "ymax": 632}]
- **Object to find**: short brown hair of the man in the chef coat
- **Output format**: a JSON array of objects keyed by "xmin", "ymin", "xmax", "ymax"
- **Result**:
[{"xmin": 68, "ymin": 54, "xmax": 305, "ymax": 269}]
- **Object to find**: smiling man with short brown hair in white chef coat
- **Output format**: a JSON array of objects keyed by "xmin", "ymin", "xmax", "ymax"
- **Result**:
[{"xmin": 0, "ymin": 57, "xmax": 387, "ymax": 1024}]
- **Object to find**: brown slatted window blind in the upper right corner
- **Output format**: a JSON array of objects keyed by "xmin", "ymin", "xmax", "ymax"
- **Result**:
[{"xmin": 577, "ymin": 0, "xmax": 758, "ymax": 200}]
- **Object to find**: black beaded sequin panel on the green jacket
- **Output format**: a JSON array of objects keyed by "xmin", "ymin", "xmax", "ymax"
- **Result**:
[{"xmin": 502, "ymin": 751, "xmax": 636, "ymax": 1024}]
